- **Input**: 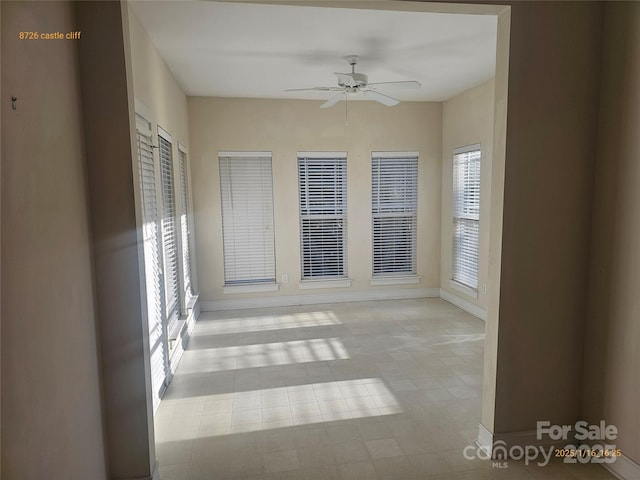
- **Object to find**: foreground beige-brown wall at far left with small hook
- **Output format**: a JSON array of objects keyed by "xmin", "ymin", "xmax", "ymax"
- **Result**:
[{"xmin": 1, "ymin": 2, "xmax": 106, "ymax": 480}]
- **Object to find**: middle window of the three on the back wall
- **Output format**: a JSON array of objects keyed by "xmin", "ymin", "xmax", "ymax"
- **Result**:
[{"xmin": 298, "ymin": 152, "xmax": 347, "ymax": 280}]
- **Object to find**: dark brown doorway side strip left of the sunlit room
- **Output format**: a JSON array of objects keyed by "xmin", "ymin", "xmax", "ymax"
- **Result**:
[{"xmin": 74, "ymin": 2, "xmax": 155, "ymax": 479}]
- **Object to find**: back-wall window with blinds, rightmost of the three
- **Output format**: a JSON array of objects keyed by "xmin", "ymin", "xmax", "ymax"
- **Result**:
[{"xmin": 371, "ymin": 152, "xmax": 418, "ymax": 277}]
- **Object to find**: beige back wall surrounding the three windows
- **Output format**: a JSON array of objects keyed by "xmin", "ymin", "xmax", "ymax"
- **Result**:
[{"xmin": 189, "ymin": 97, "xmax": 441, "ymax": 301}]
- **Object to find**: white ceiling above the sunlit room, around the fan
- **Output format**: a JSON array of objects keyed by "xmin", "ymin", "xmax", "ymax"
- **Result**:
[{"xmin": 131, "ymin": 0, "xmax": 496, "ymax": 101}]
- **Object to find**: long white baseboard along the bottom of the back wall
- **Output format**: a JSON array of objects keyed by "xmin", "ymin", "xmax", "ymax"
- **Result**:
[{"xmin": 201, "ymin": 288, "xmax": 440, "ymax": 312}]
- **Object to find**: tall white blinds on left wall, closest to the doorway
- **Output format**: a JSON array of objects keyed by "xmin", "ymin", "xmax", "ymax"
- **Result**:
[{"xmin": 136, "ymin": 114, "xmax": 168, "ymax": 410}]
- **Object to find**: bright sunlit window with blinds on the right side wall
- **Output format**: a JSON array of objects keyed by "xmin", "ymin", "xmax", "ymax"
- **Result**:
[{"xmin": 453, "ymin": 145, "xmax": 480, "ymax": 290}]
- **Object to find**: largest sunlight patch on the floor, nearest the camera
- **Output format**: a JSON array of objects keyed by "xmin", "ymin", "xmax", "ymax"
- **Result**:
[{"xmin": 156, "ymin": 378, "xmax": 402, "ymax": 442}]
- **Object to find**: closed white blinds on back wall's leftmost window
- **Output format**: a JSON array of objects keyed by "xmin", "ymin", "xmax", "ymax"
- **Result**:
[{"xmin": 218, "ymin": 152, "xmax": 276, "ymax": 286}]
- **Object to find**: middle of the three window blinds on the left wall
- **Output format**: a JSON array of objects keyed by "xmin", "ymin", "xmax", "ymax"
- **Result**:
[{"xmin": 158, "ymin": 135, "xmax": 181, "ymax": 325}]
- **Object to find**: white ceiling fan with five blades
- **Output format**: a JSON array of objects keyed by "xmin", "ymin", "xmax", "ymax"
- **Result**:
[{"xmin": 285, "ymin": 55, "xmax": 421, "ymax": 108}]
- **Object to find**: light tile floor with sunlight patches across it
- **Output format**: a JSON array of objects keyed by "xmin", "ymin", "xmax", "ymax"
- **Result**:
[{"xmin": 155, "ymin": 299, "xmax": 613, "ymax": 480}]
